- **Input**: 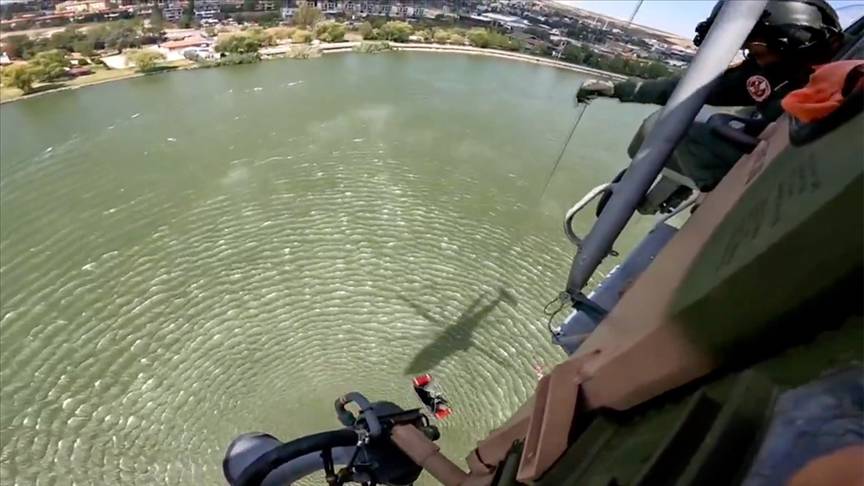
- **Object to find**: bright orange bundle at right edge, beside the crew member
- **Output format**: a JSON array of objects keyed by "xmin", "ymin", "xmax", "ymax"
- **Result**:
[{"xmin": 781, "ymin": 60, "xmax": 864, "ymax": 123}]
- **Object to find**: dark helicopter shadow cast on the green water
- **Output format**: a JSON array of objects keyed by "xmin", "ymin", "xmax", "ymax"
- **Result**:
[{"xmin": 399, "ymin": 288, "xmax": 518, "ymax": 375}]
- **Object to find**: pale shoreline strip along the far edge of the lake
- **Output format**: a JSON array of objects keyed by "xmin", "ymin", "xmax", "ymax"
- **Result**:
[{"xmin": 0, "ymin": 42, "xmax": 627, "ymax": 105}]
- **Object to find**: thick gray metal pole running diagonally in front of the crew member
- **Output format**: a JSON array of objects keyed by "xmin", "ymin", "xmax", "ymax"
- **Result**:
[{"xmin": 566, "ymin": 0, "xmax": 768, "ymax": 301}]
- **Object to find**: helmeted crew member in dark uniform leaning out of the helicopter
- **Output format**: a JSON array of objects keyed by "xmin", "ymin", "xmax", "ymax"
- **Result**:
[{"xmin": 577, "ymin": 0, "xmax": 844, "ymax": 192}]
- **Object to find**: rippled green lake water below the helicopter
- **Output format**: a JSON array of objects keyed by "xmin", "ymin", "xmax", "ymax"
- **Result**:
[{"xmin": 0, "ymin": 54, "xmax": 650, "ymax": 485}]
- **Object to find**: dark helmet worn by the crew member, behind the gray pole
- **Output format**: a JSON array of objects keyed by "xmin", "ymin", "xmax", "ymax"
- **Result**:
[{"xmin": 693, "ymin": 0, "xmax": 842, "ymax": 52}]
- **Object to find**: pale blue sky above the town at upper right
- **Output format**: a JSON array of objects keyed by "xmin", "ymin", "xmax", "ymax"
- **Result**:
[{"xmin": 559, "ymin": 0, "xmax": 864, "ymax": 37}]
